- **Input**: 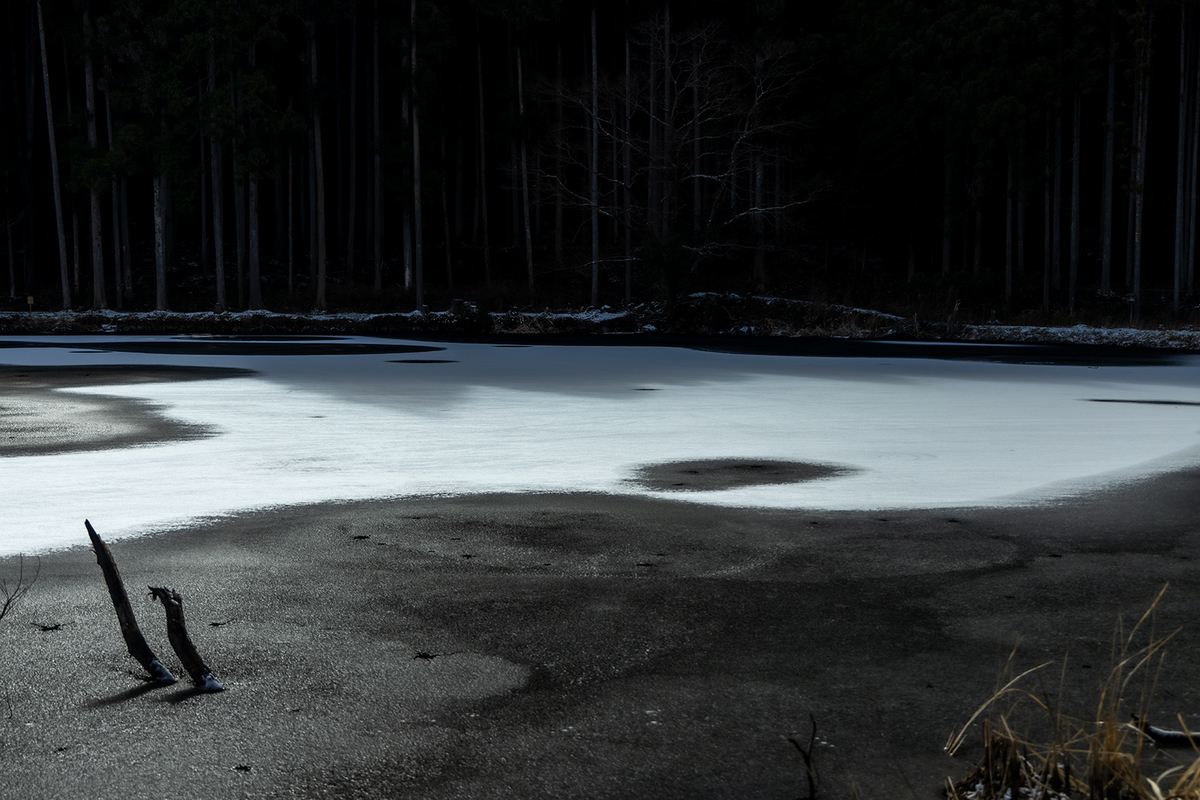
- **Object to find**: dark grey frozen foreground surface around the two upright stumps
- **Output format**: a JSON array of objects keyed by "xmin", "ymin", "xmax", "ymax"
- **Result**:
[{"xmin": 0, "ymin": 470, "xmax": 1200, "ymax": 798}]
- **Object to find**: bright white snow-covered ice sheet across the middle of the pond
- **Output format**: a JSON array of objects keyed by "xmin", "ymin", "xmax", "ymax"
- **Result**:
[{"xmin": 0, "ymin": 336, "xmax": 1200, "ymax": 554}]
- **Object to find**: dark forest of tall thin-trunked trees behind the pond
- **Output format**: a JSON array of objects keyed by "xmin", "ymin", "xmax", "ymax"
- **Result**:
[{"xmin": 0, "ymin": 0, "xmax": 1200, "ymax": 321}]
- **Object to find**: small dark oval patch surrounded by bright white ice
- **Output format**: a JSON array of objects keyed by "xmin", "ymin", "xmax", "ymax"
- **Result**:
[{"xmin": 631, "ymin": 458, "xmax": 859, "ymax": 492}]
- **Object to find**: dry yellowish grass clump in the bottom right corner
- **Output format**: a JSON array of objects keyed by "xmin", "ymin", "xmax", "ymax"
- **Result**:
[{"xmin": 946, "ymin": 587, "xmax": 1200, "ymax": 800}]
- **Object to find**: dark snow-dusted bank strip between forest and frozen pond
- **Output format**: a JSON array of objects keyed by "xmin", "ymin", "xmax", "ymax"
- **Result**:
[{"xmin": 0, "ymin": 293, "xmax": 1200, "ymax": 350}]
